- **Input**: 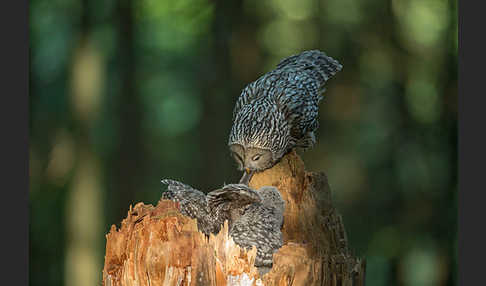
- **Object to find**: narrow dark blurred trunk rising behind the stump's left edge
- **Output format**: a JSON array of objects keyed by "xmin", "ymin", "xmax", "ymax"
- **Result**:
[{"xmin": 110, "ymin": 0, "xmax": 145, "ymax": 218}]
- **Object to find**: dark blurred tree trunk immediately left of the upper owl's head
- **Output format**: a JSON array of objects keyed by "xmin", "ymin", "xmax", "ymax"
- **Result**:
[{"xmin": 198, "ymin": 0, "xmax": 251, "ymax": 189}]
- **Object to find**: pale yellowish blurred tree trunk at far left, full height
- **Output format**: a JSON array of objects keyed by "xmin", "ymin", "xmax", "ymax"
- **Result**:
[{"xmin": 64, "ymin": 0, "xmax": 104, "ymax": 286}]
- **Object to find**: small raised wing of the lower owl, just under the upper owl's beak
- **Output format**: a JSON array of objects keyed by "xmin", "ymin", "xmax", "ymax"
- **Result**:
[{"xmin": 206, "ymin": 184, "xmax": 262, "ymax": 213}]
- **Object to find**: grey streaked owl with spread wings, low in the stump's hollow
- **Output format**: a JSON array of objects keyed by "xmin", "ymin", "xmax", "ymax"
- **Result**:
[{"xmin": 162, "ymin": 179, "xmax": 285, "ymax": 274}]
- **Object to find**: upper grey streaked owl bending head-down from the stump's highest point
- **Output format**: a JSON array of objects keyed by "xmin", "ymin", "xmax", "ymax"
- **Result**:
[{"xmin": 228, "ymin": 50, "xmax": 342, "ymax": 184}]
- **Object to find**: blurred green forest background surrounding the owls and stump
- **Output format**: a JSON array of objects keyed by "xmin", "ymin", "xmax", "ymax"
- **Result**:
[{"xmin": 29, "ymin": 0, "xmax": 458, "ymax": 285}]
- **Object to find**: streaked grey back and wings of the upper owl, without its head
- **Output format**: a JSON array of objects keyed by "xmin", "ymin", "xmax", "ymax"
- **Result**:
[{"xmin": 233, "ymin": 50, "xmax": 342, "ymax": 138}]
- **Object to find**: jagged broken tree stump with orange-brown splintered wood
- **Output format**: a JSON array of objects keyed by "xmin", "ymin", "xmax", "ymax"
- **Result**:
[{"xmin": 103, "ymin": 152, "xmax": 365, "ymax": 286}]
